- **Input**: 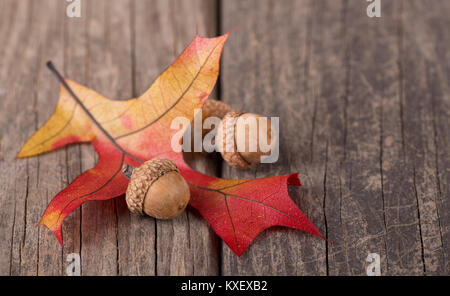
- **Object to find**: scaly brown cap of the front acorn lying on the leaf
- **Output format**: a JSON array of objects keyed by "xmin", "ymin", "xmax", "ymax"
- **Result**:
[{"xmin": 126, "ymin": 158, "xmax": 179, "ymax": 215}]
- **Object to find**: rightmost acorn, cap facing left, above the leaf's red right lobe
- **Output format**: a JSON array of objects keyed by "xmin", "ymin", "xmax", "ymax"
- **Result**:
[{"xmin": 216, "ymin": 110, "xmax": 277, "ymax": 169}]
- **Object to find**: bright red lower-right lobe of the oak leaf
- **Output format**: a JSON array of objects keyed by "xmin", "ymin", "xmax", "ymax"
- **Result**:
[{"xmin": 180, "ymin": 161, "xmax": 323, "ymax": 255}]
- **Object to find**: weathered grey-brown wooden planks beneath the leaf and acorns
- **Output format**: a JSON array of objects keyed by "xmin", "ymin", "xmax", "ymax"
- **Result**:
[{"xmin": 0, "ymin": 0, "xmax": 450, "ymax": 275}]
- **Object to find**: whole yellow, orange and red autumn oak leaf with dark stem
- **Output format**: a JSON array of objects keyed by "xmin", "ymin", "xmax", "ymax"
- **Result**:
[{"xmin": 18, "ymin": 34, "xmax": 322, "ymax": 255}]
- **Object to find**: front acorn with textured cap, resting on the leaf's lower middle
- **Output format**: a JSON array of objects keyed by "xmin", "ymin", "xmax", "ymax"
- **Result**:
[{"xmin": 123, "ymin": 158, "xmax": 190, "ymax": 219}]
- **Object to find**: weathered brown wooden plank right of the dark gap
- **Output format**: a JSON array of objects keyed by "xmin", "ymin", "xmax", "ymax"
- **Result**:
[{"xmin": 222, "ymin": 1, "xmax": 449, "ymax": 275}]
